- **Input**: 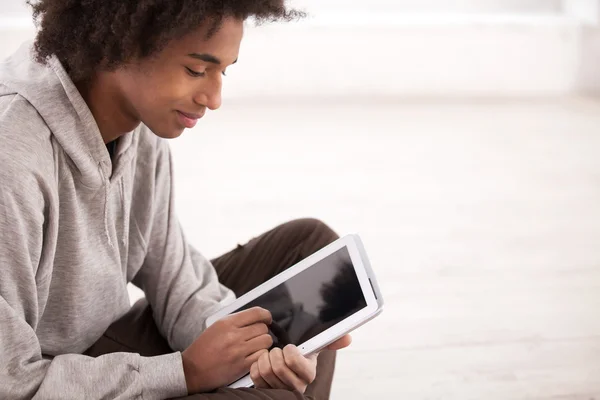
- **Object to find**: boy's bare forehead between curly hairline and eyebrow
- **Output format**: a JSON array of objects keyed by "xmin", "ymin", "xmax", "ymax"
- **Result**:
[{"xmin": 165, "ymin": 18, "xmax": 244, "ymax": 65}]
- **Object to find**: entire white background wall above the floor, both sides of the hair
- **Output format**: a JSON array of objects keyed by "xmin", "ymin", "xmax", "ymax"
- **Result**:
[{"xmin": 0, "ymin": 0, "xmax": 600, "ymax": 99}]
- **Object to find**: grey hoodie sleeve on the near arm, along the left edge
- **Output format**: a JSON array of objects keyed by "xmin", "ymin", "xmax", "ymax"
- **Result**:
[{"xmin": 0, "ymin": 97, "xmax": 187, "ymax": 400}]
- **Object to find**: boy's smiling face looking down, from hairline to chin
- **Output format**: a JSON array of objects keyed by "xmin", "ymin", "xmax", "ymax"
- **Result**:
[{"xmin": 117, "ymin": 18, "xmax": 243, "ymax": 138}]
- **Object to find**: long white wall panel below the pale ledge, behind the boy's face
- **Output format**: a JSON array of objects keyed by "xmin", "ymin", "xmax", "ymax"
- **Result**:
[{"xmin": 221, "ymin": 22, "xmax": 579, "ymax": 97}]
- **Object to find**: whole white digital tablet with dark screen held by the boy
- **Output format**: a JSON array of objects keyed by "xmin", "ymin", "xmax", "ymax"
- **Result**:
[{"xmin": 206, "ymin": 234, "xmax": 383, "ymax": 388}]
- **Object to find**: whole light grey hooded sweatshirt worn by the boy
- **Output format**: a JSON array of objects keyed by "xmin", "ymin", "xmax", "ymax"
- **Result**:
[{"xmin": 0, "ymin": 43, "xmax": 234, "ymax": 399}]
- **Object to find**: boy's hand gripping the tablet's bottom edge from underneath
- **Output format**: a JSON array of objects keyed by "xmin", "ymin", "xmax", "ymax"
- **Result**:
[{"xmin": 250, "ymin": 335, "xmax": 352, "ymax": 393}]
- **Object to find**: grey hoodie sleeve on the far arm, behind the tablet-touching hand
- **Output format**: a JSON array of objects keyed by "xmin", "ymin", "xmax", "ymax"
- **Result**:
[{"xmin": 133, "ymin": 139, "xmax": 235, "ymax": 351}]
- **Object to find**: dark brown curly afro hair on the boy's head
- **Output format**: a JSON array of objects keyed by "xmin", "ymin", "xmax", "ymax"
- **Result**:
[{"xmin": 27, "ymin": 0, "xmax": 304, "ymax": 81}]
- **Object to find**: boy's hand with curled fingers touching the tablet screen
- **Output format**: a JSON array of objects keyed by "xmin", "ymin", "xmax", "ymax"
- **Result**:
[{"xmin": 181, "ymin": 307, "xmax": 273, "ymax": 394}]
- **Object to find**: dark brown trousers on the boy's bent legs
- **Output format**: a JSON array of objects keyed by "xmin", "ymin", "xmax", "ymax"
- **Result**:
[{"xmin": 85, "ymin": 219, "xmax": 338, "ymax": 400}]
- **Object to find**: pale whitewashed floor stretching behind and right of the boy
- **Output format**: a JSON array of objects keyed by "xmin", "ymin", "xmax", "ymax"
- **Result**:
[{"xmin": 129, "ymin": 98, "xmax": 600, "ymax": 400}]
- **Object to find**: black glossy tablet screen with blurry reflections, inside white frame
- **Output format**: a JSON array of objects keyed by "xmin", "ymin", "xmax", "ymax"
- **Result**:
[{"xmin": 236, "ymin": 246, "xmax": 367, "ymax": 348}]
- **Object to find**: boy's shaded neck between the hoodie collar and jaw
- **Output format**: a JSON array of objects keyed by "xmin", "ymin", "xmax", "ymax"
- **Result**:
[{"xmin": 75, "ymin": 72, "xmax": 140, "ymax": 143}]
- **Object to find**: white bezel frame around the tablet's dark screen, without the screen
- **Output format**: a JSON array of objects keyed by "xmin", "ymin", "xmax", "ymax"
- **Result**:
[{"xmin": 206, "ymin": 234, "xmax": 383, "ymax": 387}]
